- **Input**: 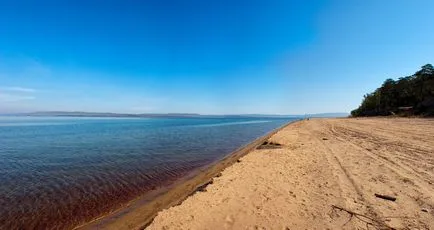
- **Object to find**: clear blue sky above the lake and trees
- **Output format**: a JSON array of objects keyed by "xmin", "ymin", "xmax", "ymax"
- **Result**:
[{"xmin": 0, "ymin": 0, "xmax": 434, "ymax": 114}]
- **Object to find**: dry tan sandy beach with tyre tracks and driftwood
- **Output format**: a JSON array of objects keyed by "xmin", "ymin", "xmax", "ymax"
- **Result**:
[{"xmin": 147, "ymin": 118, "xmax": 434, "ymax": 229}]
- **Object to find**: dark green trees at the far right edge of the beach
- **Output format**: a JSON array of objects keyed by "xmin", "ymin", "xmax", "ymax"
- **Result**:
[{"xmin": 351, "ymin": 64, "xmax": 434, "ymax": 117}]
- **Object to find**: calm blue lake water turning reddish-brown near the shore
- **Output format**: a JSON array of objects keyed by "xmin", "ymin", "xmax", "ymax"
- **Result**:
[{"xmin": 0, "ymin": 117, "xmax": 291, "ymax": 229}]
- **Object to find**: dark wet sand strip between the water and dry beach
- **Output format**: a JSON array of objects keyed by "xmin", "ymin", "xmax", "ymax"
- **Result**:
[{"xmin": 74, "ymin": 119, "xmax": 301, "ymax": 230}]
